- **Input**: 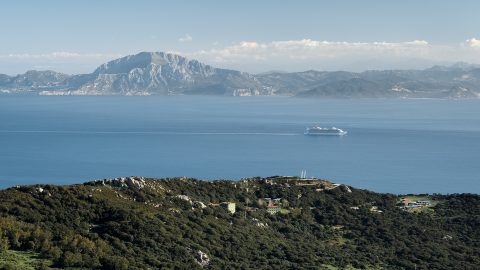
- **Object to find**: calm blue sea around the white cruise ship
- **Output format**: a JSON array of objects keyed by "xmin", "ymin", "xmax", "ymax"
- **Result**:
[{"xmin": 0, "ymin": 96, "xmax": 480, "ymax": 193}]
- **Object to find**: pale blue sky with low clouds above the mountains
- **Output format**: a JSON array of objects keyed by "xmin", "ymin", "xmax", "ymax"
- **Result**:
[{"xmin": 0, "ymin": 0, "xmax": 480, "ymax": 75}]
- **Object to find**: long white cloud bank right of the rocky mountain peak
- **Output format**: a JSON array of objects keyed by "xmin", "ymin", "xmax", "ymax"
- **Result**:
[{"xmin": 186, "ymin": 39, "xmax": 480, "ymax": 72}]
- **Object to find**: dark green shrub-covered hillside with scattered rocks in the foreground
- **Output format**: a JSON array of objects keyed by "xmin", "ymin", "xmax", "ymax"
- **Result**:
[{"xmin": 0, "ymin": 177, "xmax": 480, "ymax": 269}]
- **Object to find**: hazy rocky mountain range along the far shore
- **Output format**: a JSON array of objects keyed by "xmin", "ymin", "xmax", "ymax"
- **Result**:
[{"xmin": 0, "ymin": 52, "xmax": 480, "ymax": 98}]
